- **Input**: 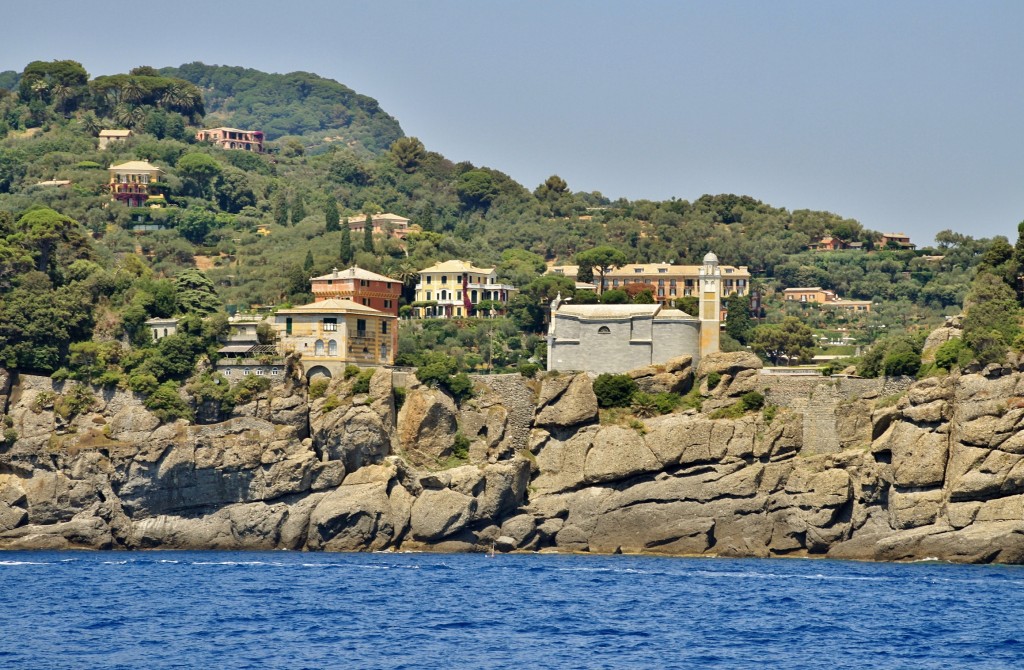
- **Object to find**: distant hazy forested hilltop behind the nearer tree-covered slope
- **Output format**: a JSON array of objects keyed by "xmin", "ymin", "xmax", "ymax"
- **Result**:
[{"xmin": 160, "ymin": 61, "xmax": 402, "ymax": 153}]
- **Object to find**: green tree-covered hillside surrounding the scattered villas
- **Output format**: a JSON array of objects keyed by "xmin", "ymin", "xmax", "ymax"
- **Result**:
[{"xmin": 0, "ymin": 60, "xmax": 1024, "ymax": 387}]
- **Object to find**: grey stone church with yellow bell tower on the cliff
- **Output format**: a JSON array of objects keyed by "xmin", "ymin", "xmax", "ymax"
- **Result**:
[{"xmin": 548, "ymin": 253, "xmax": 722, "ymax": 374}]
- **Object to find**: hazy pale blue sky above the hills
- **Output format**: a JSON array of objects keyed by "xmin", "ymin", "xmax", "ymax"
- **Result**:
[{"xmin": 0, "ymin": 0, "xmax": 1024, "ymax": 243}]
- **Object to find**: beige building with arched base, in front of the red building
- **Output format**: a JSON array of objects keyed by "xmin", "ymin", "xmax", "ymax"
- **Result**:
[{"xmin": 273, "ymin": 298, "xmax": 398, "ymax": 377}]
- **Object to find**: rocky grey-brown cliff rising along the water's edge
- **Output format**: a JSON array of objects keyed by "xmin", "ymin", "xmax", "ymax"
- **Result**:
[{"xmin": 0, "ymin": 354, "xmax": 1024, "ymax": 562}]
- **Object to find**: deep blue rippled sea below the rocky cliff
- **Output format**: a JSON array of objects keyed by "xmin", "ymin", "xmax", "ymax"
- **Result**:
[{"xmin": 0, "ymin": 551, "xmax": 1024, "ymax": 670}]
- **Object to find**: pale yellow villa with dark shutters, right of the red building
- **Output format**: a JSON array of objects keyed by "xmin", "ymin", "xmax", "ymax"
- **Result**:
[{"xmin": 413, "ymin": 260, "xmax": 515, "ymax": 318}]
